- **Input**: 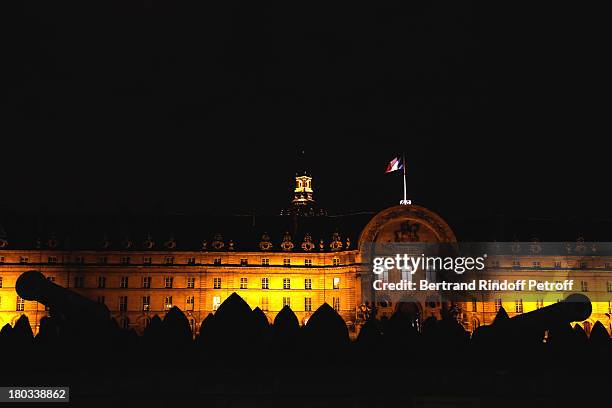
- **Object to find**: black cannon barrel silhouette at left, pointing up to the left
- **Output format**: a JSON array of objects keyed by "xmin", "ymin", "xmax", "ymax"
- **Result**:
[{"xmin": 15, "ymin": 270, "xmax": 110, "ymax": 323}]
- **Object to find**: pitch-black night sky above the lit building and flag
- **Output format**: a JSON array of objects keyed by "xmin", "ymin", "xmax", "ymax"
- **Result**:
[{"xmin": 0, "ymin": 1, "xmax": 610, "ymax": 226}]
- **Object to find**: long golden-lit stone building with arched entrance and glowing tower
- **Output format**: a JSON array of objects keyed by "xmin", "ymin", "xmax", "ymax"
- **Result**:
[{"xmin": 0, "ymin": 173, "xmax": 612, "ymax": 334}]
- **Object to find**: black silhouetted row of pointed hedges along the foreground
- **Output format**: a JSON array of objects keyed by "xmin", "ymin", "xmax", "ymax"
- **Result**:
[{"xmin": 0, "ymin": 293, "xmax": 612, "ymax": 403}]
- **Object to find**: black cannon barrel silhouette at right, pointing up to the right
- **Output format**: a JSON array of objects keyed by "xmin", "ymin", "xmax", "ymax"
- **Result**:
[{"xmin": 509, "ymin": 293, "xmax": 592, "ymax": 330}]
